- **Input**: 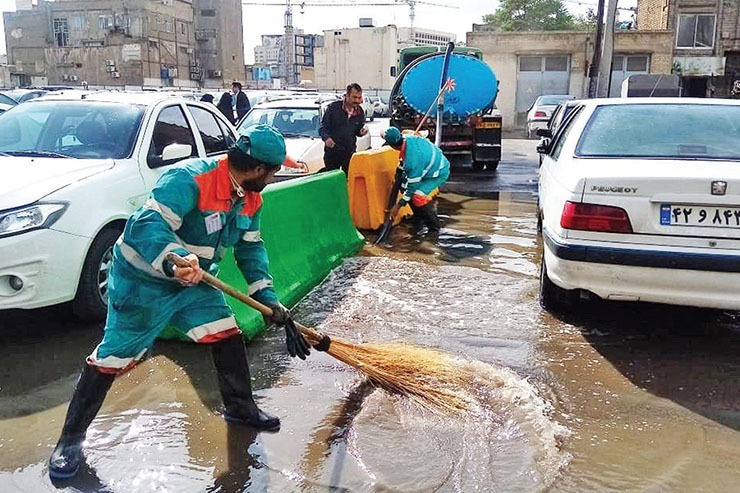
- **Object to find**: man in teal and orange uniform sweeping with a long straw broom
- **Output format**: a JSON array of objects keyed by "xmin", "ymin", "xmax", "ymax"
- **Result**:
[{"xmin": 49, "ymin": 125, "xmax": 316, "ymax": 478}]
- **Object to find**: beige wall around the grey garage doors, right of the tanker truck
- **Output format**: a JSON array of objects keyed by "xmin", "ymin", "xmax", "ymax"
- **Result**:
[{"xmin": 467, "ymin": 30, "xmax": 673, "ymax": 129}]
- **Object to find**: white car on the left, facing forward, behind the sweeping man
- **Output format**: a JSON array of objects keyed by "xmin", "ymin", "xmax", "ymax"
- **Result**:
[{"xmin": 0, "ymin": 92, "xmax": 236, "ymax": 320}]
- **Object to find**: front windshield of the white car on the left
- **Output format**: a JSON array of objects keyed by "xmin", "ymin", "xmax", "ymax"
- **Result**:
[{"xmin": 0, "ymin": 100, "xmax": 144, "ymax": 159}]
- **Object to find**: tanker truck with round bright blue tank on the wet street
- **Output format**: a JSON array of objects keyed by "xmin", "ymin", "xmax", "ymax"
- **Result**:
[{"xmin": 389, "ymin": 46, "xmax": 502, "ymax": 171}]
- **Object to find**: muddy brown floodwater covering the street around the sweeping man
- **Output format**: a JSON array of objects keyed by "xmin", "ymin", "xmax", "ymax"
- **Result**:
[{"xmin": 0, "ymin": 193, "xmax": 740, "ymax": 493}]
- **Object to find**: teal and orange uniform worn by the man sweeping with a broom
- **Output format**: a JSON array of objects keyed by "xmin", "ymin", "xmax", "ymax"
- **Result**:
[{"xmin": 87, "ymin": 157, "xmax": 278, "ymax": 373}]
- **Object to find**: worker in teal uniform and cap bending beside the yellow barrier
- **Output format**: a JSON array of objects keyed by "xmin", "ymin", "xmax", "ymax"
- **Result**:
[{"xmin": 383, "ymin": 127, "xmax": 450, "ymax": 235}]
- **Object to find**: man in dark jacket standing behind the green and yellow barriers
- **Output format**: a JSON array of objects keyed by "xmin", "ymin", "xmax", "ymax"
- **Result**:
[{"xmin": 319, "ymin": 83, "xmax": 368, "ymax": 174}]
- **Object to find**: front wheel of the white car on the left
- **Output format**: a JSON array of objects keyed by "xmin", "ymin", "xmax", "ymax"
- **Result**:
[{"xmin": 72, "ymin": 229, "xmax": 121, "ymax": 322}]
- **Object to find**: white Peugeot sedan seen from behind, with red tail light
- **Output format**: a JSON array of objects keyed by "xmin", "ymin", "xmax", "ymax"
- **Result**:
[{"xmin": 538, "ymin": 98, "xmax": 740, "ymax": 310}]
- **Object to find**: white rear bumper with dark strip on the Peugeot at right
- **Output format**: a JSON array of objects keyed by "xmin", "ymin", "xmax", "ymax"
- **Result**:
[{"xmin": 543, "ymin": 232, "xmax": 740, "ymax": 310}]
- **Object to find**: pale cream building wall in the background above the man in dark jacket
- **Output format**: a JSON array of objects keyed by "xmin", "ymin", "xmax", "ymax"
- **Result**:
[{"xmin": 315, "ymin": 26, "xmax": 398, "ymax": 90}]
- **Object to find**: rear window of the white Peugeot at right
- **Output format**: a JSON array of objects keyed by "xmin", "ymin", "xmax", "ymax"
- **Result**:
[{"xmin": 576, "ymin": 103, "xmax": 740, "ymax": 160}]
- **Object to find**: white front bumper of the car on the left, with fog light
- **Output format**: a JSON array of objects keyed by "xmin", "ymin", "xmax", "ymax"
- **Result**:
[{"xmin": 0, "ymin": 229, "xmax": 90, "ymax": 310}]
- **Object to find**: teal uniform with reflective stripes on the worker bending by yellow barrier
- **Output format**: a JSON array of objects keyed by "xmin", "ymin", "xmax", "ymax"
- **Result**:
[{"xmin": 394, "ymin": 135, "xmax": 450, "ymax": 207}]
